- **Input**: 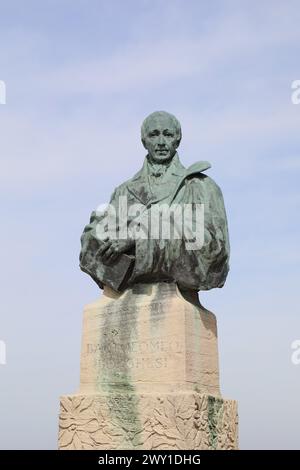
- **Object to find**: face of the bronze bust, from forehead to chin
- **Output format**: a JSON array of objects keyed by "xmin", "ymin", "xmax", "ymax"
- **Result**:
[{"xmin": 143, "ymin": 116, "xmax": 178, "ymax": 163}]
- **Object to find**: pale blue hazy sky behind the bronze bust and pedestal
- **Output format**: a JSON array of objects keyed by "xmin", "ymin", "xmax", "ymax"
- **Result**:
[{"xmin": 0, "ymin": 0, "xmax": 300, "ymax": 448}]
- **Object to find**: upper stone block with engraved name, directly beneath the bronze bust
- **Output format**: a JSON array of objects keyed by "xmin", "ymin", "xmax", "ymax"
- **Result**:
[{"xmin": 80, "ymin": 283, "xmax": 219, "ymax": 395}]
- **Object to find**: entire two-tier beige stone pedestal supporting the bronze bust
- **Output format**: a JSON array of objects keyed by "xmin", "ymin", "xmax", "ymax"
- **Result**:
[{"xmin": 59, "ymin": 283, "xmax": 237, "ymax": 450}]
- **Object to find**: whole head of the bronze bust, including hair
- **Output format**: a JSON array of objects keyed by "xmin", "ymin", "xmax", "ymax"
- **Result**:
[{"xmin": 141, "ymin": 111, "xmax": 181, "ymax": 163}]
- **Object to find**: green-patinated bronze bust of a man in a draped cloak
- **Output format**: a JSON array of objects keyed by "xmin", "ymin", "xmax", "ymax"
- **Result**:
[{"xmin": 80, "ymin": 111, "xmax": 229, "ymax": 291}]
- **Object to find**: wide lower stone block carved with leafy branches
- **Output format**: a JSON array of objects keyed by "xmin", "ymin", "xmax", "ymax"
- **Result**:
[{"xmin": 59, "ymin": 391, "xmax": 238, "ymax": 450}]
